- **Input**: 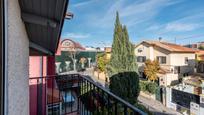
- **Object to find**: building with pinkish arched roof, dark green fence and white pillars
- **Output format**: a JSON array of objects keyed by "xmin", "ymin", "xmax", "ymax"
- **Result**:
[{"xmin": 55, "ymin": 39, "xmax": 101, "ymax": 73}]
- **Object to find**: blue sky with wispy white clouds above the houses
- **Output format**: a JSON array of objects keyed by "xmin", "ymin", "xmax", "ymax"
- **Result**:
[{"xmin": 61, "ymin": 0, "xmax": 204, "ymax": 47}]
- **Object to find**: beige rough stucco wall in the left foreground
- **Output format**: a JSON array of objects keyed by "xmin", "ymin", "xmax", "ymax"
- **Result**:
[{"xmin": 7, "ymin": 0, "xmax": 29, "ymax": 115}]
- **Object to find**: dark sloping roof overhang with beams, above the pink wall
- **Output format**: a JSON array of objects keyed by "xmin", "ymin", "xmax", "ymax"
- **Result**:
[{"xmin": 19, "ymin": 0, "xmax": 69, "ymax": 55}]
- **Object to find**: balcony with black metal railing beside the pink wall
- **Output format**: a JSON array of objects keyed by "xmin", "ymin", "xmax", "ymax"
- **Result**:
[{"xmin": 29, "ymin": 74, "xmax": 146, "ymax": 115}]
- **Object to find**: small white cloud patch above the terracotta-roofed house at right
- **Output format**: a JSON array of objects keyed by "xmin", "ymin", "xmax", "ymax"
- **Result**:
[{"xmin": 165, "ymin": 23, "xmax": 200, "ymax": 32}]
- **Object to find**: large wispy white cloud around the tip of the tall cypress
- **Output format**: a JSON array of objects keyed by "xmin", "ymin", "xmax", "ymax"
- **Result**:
[{"xmin": 93, "ymin": 0, "xmax": 178, "ymax": 27}]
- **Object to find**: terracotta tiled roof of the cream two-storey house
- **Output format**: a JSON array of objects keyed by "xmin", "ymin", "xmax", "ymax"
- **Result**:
[{"xmin": 136, "ymin": 41, "xmax": 196, "ymax": 53}]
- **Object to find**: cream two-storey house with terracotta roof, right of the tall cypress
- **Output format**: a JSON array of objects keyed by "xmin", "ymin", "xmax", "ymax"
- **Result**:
[{"xmin": 135, "ymin": 41, "xmax": 195, "ymax": 86}]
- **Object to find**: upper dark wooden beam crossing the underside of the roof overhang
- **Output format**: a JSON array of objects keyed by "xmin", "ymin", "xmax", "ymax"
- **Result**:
[{"xmin": 21, "ymin": 12, "xmax": 59, "ymax": 28}]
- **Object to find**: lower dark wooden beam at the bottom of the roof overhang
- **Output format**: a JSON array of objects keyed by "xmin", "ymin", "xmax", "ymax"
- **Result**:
[{"xmin": 29, "ymin": 42, "xmax": 54, "ymax": 55}]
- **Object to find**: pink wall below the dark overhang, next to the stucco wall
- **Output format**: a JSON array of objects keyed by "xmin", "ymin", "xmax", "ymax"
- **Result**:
[{"xmin": 29, "ymin": 56, "xmax": 47, "ymax": 115}]
